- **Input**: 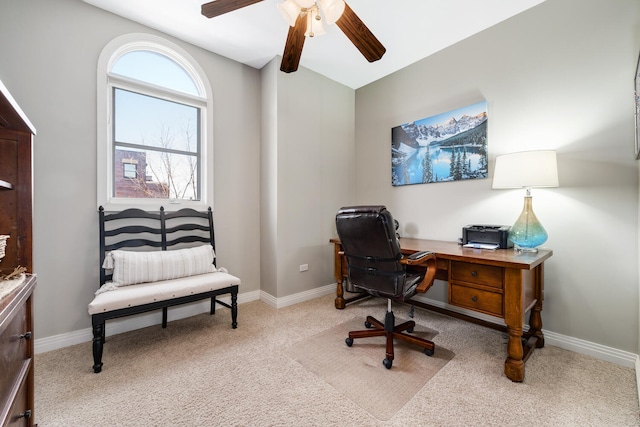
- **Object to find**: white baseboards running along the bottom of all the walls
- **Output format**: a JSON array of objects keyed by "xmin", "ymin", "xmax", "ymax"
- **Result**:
[{"xmin": 34, "ymin": 284, "xmax": 640, "ymax": 372}]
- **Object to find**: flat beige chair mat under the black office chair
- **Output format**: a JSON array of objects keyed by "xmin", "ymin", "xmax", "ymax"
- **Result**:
[{"xmin": 285, "ymin": 318, "xmax": 453, "ymax": 421}]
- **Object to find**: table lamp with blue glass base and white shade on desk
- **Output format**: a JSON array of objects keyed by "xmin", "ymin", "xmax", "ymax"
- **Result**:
[{"xmin": 492, "ymin": 151, "xmax": 558, "ymax": 252}]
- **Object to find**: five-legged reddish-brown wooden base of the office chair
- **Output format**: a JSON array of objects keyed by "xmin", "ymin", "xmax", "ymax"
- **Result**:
[{"xmin": 345, "ymin": 311, "xmax": 435, "ymax": 369}]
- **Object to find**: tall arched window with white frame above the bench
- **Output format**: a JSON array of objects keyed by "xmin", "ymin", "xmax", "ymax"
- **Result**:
[{"xmin": 97, "ymin": 34, "xmax": 213, "ymax": 209}]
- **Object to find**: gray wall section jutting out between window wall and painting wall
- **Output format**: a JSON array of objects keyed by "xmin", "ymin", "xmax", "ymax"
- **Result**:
[{"xmin": 261, "ymin": 57, "xmax": 355, "ymax": 298}]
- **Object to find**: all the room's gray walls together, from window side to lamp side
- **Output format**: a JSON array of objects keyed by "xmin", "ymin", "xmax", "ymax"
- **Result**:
[{"xmin": 0, "ymin": 0, "xmax": 640, "ymax": 358}]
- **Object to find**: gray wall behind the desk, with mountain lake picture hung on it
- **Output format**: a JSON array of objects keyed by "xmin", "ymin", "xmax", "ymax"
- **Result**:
[{"xmin": 356, "ymin": 0, "xmax": 640, "ymax": 353}]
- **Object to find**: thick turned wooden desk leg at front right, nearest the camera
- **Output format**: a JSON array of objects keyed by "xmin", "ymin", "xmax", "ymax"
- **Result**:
[{"xmin": 504, "ymin": 268, "xmax": 524, "ymax": 382}]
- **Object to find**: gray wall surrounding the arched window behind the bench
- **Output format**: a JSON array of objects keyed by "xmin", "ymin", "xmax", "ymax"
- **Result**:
[{"xmin": 0, "ymin": 0, "xmax": 261, "ymax": 338}]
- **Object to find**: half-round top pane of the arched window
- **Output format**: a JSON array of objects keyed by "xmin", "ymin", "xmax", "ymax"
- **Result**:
[{"xmin": 111, "ymin": 50, "xmax": 198, "ymax": 96}]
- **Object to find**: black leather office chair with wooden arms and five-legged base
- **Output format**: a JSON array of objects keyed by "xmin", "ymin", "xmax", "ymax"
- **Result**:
[{"xmin": 336, "ymin": 206, "xmax": 436, "ymax": 369}]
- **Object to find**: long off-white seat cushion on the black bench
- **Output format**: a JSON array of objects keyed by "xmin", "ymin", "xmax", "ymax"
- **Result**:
[{"xmin": 89, "ymin": 271, "xmax": 240, "ymax": 314}]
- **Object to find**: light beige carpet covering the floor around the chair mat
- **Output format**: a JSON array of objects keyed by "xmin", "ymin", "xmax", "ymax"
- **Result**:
[{"xmin": 35, "ymin": 295, "xmax": 640, "ymax": 427}]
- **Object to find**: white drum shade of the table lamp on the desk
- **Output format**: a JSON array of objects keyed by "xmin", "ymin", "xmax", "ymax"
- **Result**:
[{"xmin": 492, "ymin": 151, "xmax": 559, "ymax": 189}]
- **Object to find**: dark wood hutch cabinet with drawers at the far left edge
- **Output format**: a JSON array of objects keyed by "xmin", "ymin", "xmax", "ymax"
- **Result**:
[{"xmin": 0, "ymin": 81, "xmax": 36, "ymax": 427}]
